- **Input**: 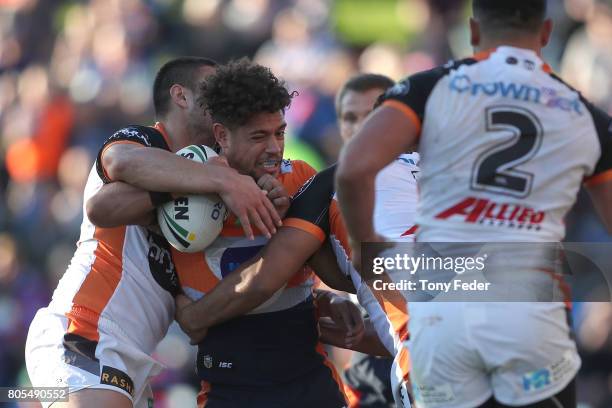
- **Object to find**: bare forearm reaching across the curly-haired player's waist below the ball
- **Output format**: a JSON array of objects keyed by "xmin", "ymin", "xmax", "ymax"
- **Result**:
[{"xmin": 177, "ymin": 227, "xmax": 354, "ymax": 340}]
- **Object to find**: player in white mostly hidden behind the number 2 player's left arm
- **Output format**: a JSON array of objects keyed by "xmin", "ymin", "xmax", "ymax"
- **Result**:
[{"xmin": 336, "ymin": 74, "xmax": 418, "ymax": 408}]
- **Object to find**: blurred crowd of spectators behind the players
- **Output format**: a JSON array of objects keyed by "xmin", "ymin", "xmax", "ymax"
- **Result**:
[{"xmin": 0, "ymin": 0, "xmax": 612, "ymax": 408}]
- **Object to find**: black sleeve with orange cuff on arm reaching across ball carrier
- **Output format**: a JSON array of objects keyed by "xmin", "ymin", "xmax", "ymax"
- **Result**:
[{"xmin": 283, "ymin": 165, "xmax": 336, "ymax": 242}]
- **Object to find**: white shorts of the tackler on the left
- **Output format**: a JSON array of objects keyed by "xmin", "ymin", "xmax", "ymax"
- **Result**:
[{"xmin": 25, "ymin": 308, "xmax": 163, "ymax": 408}]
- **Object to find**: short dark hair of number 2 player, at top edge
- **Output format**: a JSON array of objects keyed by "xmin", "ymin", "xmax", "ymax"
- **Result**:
[{"xmin": 472, "ymin": 0, "xmax": 546, "ymax": 31}]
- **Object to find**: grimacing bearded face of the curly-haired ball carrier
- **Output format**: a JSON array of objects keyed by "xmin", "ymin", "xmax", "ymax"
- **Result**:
[{"xmin": 215, "ymin": 111, "xmax": 287, "ymax": 180}]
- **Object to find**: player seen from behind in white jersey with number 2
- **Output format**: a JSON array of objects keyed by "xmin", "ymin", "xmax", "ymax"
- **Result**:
[{"xmin": 337, "ymin": 0, "xmax": 612, "ymax": 408}]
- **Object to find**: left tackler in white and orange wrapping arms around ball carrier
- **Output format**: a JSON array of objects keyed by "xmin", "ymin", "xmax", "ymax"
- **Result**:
[{"xmin": 25, "ymin": 57, "xmax": 279, "ymax": 407}]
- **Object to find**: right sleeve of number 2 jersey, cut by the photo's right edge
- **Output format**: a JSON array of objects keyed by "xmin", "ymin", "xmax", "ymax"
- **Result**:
[{"xmin": 585, "ymin": 102, "xmax": 612, "ymax": 186}]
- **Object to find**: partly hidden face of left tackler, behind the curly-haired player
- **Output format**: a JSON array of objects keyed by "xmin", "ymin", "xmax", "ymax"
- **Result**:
[{"xmin": 186, "ymin": 66, "xmax": 216, "ymax": 147}]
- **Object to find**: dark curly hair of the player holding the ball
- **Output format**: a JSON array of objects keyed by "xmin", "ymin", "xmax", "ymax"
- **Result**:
[{"xmin": 198, "ymin": 58, "xmax": 297, "ymax": 128}]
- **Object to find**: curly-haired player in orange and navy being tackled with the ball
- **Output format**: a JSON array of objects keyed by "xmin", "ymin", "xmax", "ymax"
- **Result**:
[{"xmin": 166, "ymin": 59, "xmax": 349, "ymax": 408}]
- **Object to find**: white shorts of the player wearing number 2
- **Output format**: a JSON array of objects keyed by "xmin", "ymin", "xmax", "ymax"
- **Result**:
[{"xmin": 407, "ymin": 302, "xmax": 580, "ymax": 408}]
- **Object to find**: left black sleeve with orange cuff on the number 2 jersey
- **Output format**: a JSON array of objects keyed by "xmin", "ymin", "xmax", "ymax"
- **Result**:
[{"xmin": 377, "ymin": 67, "xmax": 447, "ymax": 135}]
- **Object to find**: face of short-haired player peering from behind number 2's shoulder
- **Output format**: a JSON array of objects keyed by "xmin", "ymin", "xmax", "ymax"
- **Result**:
[{"xmin": 338, "ymin": 88, "xmax": 385, "ymax": 143}]
